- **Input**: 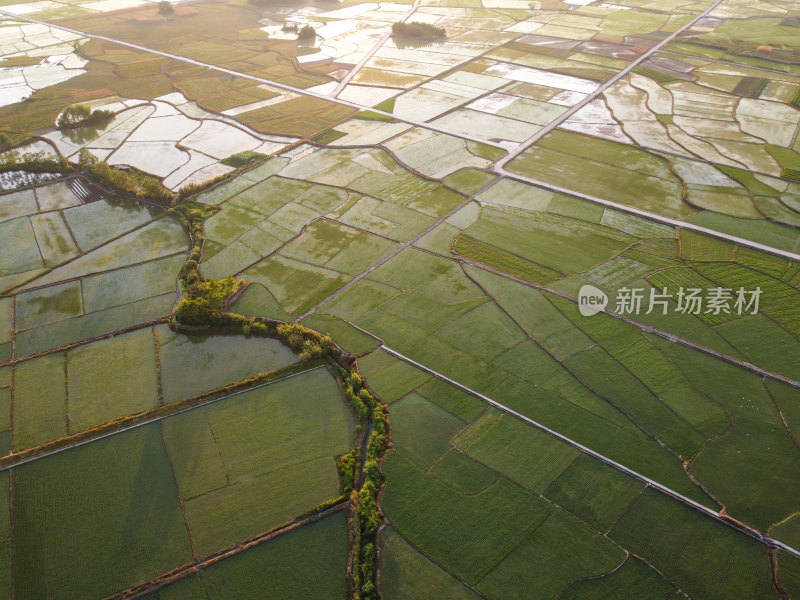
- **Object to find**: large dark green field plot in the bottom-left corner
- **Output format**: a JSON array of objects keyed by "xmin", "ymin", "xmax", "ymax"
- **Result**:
[{"xmin": 13, "ymin": 424, "xmax": 192, "ymax": 600}]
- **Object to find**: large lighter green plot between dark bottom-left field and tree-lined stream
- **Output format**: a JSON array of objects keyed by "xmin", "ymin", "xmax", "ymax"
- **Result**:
[{"xmin": 164, "ymin": 369, "xmax": 354, "ymax": 555}]
